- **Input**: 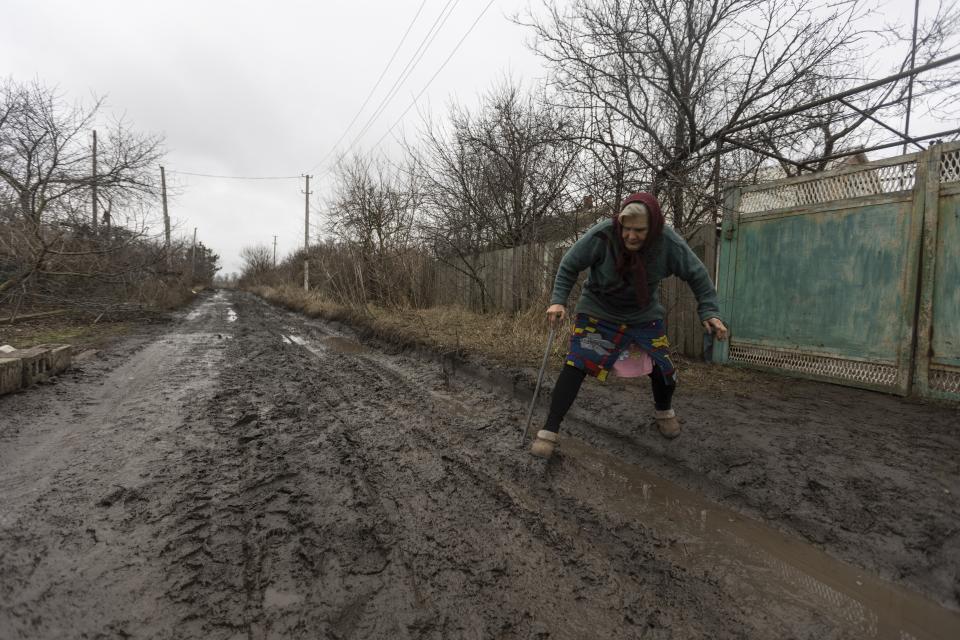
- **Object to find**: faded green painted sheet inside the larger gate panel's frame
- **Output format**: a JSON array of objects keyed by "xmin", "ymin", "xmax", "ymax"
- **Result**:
[{"xmin": 731, "ymin": 202, "xmax": 912, "ymax": 363}]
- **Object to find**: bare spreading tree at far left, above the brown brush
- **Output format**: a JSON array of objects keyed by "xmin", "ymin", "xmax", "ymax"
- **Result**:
[{"xmin": 0, "ymin": 80, "xmax": 161, "ymax": 293}]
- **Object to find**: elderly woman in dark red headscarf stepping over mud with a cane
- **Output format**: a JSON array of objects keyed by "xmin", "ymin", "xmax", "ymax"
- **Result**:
[{"xmin": 530, "ymin": 193, "xmax": 727, "ymax": 458}]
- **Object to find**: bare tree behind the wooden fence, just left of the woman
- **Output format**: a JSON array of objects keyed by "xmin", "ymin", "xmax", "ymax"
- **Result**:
[{"xmin": 414, "ymin": 81, "xmax": 580, "ymax": 308}]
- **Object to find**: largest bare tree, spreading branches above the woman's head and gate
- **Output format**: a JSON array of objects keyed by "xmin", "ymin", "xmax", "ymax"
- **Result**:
[{"xmin": 518, "ymin": 0, "xmax": 949, "ymax": 229}]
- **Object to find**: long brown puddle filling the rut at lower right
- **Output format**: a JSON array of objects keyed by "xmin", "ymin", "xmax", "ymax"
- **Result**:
[{"xmin": 556, "ymin": 437, "xmax": 960, "ymax": 640}]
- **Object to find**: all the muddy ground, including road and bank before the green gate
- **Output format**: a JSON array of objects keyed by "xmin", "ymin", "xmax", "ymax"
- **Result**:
[{"xmin": 0, "ymin": 292, "xmax": 960, "ymax": 640}]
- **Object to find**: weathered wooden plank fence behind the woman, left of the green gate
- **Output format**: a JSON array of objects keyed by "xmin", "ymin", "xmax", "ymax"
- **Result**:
[{"xmin": 434, "ymin": 225, "xmax": 716, "ymax": 357}]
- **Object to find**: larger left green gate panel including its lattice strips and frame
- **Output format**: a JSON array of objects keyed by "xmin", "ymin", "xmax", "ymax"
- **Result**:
[{"xmin": 715, "ymin": 154, "xmax": 925, "ymax": 394}]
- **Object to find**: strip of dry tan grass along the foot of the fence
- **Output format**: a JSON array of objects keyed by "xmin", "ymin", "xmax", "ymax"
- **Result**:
[{"xmin": 254, "ymin": 287, "xmax": 772, "ymax": 395}]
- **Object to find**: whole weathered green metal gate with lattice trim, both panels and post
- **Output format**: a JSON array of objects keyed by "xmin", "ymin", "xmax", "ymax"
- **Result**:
[{"xmin": 714, "ymin": 145, "xmax": 960, "ymax": 398}]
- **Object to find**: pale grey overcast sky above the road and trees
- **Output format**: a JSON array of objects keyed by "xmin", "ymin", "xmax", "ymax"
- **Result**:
[{"xmin": 0, "ymin": 0, "xmax": 933, "ymax": 273}]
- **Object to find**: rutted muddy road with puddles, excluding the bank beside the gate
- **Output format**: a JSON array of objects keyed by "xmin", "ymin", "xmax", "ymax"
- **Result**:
[{"xmin": 0, "ymin": 292, "xmax": 960, "ymax": 640}]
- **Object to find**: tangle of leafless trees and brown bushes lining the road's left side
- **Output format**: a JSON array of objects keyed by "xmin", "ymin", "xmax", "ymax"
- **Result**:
[{"xmin": 0, "ymin": 80, "xmax": 218, "ymax": 313}]
